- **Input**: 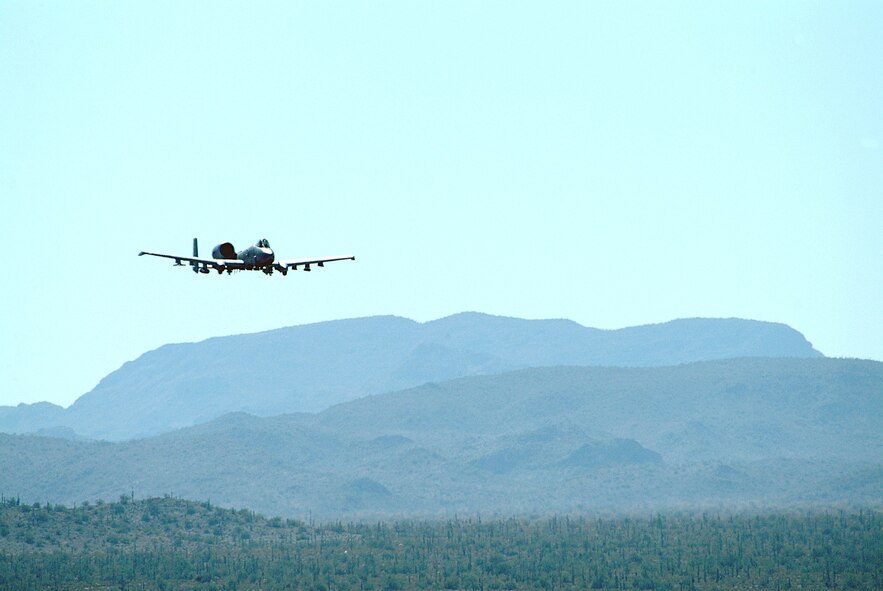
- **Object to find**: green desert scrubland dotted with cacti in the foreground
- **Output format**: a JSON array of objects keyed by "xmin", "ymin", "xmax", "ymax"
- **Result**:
[{"xmin": 0, "ymin": 497, "xmax": 883, "ymax": 591}]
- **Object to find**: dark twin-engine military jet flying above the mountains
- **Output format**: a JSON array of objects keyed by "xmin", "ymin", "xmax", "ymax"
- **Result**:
[{"xmin": 138, "ymin": 238, "xmax": 356, "ymax": 275}]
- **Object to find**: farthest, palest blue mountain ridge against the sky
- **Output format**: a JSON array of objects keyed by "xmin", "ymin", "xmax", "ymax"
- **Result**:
[{"xmin": 0, "ymin": 313, "xmax": 821, "ymax": 440}]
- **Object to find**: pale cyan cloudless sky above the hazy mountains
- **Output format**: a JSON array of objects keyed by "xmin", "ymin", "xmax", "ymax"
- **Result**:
[{"xmin": 0, "ymin": 0, "xmax": 883, "ymax": 405}]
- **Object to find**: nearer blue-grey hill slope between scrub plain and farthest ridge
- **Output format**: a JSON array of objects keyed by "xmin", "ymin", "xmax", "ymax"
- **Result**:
[{"xmin": 0, "ymin": 358, "xmax": 883, "ymax": 519}]
